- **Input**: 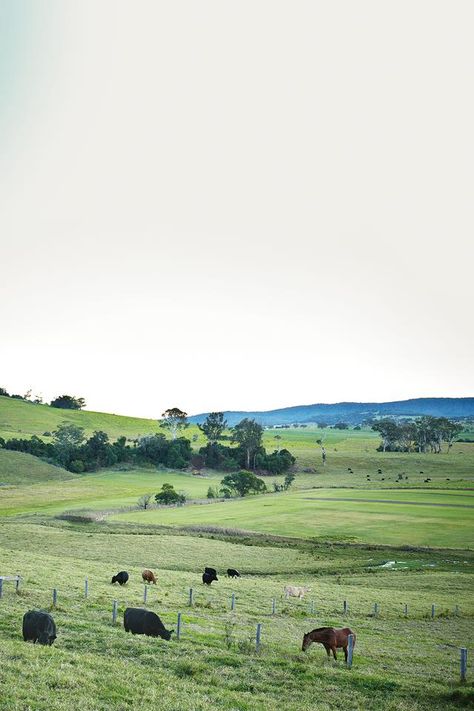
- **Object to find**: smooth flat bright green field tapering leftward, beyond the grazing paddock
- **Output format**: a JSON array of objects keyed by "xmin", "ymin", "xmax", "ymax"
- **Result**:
[{"xmin": 113, "ymin": 489, "xmax": 474, "ymax": 548}]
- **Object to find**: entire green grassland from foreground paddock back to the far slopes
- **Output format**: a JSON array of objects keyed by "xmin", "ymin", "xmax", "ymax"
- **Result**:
[{"xmin": 0, "ymin": 398, "xmax": 474, "ymax": 711}]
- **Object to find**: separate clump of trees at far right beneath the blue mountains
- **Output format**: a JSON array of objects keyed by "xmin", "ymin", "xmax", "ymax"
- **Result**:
[{"xmin": 372, "ymin": 415, "xmax": 463, "ymax": 454}]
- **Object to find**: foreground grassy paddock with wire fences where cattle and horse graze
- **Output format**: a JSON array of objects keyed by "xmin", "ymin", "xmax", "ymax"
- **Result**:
[{"xmin": 0, "ymin": 519, "xmax": 474, "ymax": 711}]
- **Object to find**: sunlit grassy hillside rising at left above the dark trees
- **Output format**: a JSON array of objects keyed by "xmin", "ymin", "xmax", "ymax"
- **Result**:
[{"xmin": 0, "ymin": 397, "xmax": 158, "ymax": 439}]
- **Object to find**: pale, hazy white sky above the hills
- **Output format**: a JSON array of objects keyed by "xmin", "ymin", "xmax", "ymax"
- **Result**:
[{"xmin": 0, "ymin": 0, "xmax": 474, "ymax": 417}]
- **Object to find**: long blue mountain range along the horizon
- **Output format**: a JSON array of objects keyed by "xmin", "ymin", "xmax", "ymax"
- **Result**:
[{"xmin": 189, "ymin": 397, "xmax": 474, "ymax": 427}]
